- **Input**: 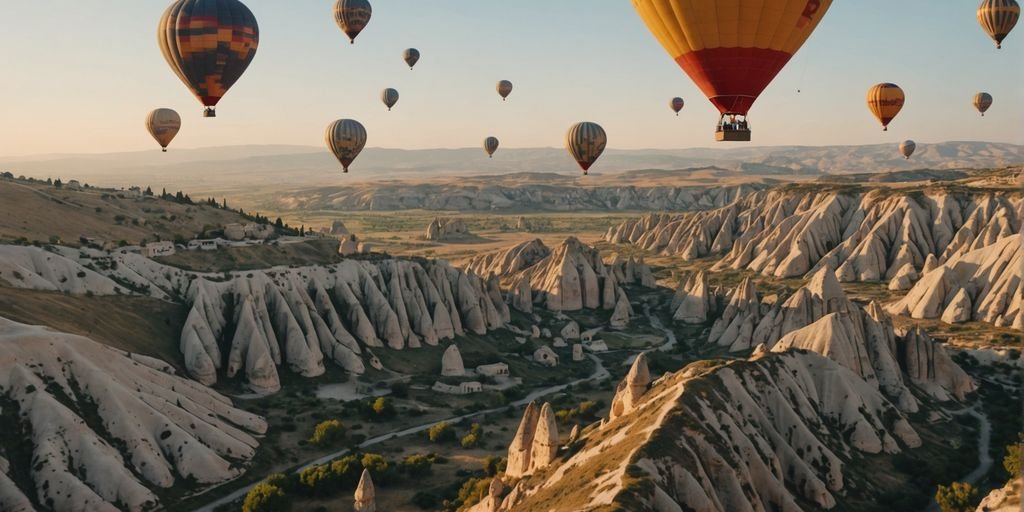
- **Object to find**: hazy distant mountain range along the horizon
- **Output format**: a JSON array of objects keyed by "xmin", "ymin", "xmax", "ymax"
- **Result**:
[{"xmin": 0, "ymin": 141, "xmax": 1024, "ymax": 195}]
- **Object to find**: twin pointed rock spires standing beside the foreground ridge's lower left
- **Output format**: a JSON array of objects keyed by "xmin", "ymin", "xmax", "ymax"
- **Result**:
[{"xmin": 505, "ymin": 401, "xmax": 559, "ymax": 478}]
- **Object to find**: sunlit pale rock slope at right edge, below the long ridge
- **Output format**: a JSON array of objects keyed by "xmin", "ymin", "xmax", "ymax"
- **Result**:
[{"xmin": 889, "ymin": 234, "xmax": 1024, "ymax": 330}]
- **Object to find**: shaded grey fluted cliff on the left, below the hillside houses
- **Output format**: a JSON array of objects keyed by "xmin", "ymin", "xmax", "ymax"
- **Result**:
[{"xmin": 0, "ymin": 246, "xmax": 510, "ymax": 392}]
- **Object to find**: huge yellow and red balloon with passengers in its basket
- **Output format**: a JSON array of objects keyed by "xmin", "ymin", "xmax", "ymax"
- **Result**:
[{"xmin": 632, "ymin": 0, "xmax": 831, "ymax": 140}]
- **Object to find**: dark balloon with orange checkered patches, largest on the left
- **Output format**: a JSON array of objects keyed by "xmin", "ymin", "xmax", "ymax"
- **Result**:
[{"xmin": 157, "ymin": 0, "xmax": 259, "ymax": 118}]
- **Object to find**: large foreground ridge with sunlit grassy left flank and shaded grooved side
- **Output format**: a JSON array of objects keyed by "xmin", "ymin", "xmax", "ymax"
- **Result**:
[{"xmin": 491, "ymin": 352, "xmax": 921, "ymax": 512}]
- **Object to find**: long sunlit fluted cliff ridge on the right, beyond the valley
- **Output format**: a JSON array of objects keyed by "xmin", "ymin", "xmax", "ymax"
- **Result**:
[{"xmin": 605, "ymin": 187, "xmax": 1024, "ymax": 282}]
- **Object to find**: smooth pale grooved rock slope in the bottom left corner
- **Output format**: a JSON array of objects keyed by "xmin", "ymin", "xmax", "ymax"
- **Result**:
[{"xmin": 0, "ymin": 318, "xmax": 266, "ymax": 512}]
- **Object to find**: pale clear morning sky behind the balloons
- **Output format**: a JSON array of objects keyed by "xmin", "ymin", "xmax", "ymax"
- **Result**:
[{"xmin": 0, "ymin": 0, "xmax": 1024, "ymax": 156}]
